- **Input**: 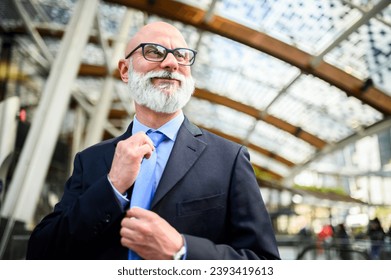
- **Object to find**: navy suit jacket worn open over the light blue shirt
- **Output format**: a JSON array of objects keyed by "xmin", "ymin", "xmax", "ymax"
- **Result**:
[{"xmin": 27, "ymin": 118, "xmax": 280, "ymax": 260}]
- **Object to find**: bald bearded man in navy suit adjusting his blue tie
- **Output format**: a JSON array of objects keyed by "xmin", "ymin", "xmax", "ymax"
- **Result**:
[{"xmin": 27, "ymin": 22, "xmax": 280, "ymax": 259}]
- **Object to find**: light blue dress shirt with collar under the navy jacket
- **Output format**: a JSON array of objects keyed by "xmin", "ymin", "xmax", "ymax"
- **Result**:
[{"xmin": 107, "ymin": 112, "xmax": 185, "ymax": 210}]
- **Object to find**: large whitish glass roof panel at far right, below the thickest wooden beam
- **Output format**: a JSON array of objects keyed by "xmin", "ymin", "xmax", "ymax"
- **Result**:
[{"xmin": 269, "ymin": 75, "xmax": 382, "ymax": 142}]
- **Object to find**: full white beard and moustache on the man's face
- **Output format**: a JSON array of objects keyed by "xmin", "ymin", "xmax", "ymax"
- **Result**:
[{"xmin": 128, "ymin": 59, "xmax": 195, "ymax": 114}]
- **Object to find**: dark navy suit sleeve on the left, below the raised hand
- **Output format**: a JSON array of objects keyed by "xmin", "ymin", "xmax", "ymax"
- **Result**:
[{"xmin": 27, "ymin": 154, "xmax": 123, "ymax": 259}]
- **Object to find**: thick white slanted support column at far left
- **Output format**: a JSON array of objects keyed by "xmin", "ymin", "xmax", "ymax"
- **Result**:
[{"xmin": 0, "ymin": 0, "xmax": 99, "ymax": 258}]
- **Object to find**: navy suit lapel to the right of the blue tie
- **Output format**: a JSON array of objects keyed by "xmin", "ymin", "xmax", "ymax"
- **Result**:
[{"xmin": 151, "ymin": 118, "xmax": 207, "ymax": 208}]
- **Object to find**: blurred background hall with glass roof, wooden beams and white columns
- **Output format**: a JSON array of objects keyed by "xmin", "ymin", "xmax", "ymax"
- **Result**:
[{"xmin": 0, "ymin": 0, "xmax": 391, "ymax": 259}]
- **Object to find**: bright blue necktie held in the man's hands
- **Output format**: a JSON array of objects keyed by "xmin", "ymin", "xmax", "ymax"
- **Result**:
[{"xmin": 129, "ymin": 130, "xmax": 166, "ymax": 260}]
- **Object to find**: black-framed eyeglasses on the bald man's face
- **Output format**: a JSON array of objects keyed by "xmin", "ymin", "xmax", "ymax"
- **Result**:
[{"xmin": 125, "ymin": 43, "xmax": 197, "ymax": 66}]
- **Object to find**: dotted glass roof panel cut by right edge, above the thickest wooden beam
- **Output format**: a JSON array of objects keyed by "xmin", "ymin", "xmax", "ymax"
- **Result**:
[{"xmin": 325, "ymin": 17, "xmax": 391, "ymax": 95}]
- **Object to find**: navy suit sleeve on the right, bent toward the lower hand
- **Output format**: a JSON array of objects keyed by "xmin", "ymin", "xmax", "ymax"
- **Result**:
[{"xmin": 185, "ymin": 147, "xmax": 280, "ymax": 260}]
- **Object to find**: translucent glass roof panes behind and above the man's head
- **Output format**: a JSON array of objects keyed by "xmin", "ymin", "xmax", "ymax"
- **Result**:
[{"xmin": 0, "ymin": 0, "xmax": 391, "ymax": 177}]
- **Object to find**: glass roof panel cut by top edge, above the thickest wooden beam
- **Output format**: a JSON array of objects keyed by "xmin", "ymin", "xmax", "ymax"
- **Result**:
[{"xmin": 216, "ymin": 0, "xmax": 361, "ymax": 54}]
